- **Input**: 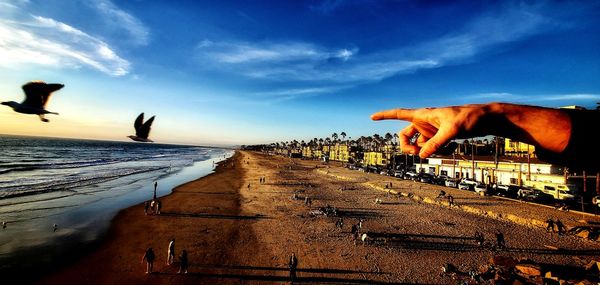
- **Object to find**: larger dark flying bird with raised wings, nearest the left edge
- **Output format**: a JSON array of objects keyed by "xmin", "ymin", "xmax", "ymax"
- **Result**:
[{"xmin": 2, "ymin": 81, "xmax": 64, "ymax": 123}]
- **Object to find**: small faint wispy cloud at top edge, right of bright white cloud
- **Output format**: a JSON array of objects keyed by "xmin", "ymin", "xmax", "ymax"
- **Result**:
[{"xmin": 87, "ymin": 0, "xmax": 150, "ymax": 45}]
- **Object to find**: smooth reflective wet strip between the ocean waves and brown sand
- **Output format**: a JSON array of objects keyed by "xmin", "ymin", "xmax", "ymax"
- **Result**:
[{"xmin": 0, "ymin": 151, "xmax": 232, "ymax": 284}]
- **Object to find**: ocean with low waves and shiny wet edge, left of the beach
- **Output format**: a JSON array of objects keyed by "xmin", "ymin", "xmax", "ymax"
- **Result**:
[{"xmin": 0, "ymin": 135, "xmax": 233, "ymax": 274}]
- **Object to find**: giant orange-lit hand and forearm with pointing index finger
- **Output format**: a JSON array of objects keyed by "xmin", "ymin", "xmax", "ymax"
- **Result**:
[{"xmin": 371, "ymin": 103, "xmax": 571, "ymax": 158}]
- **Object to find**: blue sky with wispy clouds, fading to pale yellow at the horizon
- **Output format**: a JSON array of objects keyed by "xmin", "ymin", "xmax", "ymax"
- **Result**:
[{"xmin": 0, "ymin": 0, "xmax": 600, "ymax": 145}]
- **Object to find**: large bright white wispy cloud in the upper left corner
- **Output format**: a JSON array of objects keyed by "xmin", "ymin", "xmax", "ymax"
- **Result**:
[{"xmin": 0, "ymin": 0, "xmax": 130, "ymax": 76}]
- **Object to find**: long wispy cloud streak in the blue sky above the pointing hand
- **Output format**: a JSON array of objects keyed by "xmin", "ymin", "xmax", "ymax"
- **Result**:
[{"xmin": 198, "ymin": 1, "xmax": 550, "ymax": 84}]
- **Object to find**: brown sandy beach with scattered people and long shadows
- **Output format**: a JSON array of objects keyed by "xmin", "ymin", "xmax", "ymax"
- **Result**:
[{"xmin": 40, "ymin": 151, "xmax": 600, "ymax": 284}]
